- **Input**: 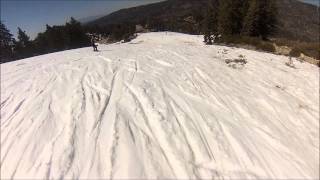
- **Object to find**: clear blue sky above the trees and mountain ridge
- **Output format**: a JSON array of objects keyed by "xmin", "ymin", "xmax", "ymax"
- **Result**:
[{"xmin": 1, "ymin": 0, "xmax": 319, "ymax": 38}]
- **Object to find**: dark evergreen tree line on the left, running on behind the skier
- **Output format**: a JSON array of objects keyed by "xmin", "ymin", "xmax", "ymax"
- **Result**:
[{"xmin": 0, "ymin": 17, "xmax": 140, "ymax": 63}]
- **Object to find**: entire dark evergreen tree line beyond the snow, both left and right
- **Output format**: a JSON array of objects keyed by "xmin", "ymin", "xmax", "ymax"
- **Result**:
[{"xmin": 0, "ymin": 0, "xmax": 277, "ymax": 62}]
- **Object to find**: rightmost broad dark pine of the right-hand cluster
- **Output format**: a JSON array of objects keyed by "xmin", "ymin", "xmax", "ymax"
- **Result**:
[{"xmin": 242, "ymin": 0, "xmax": 277, "ymax": 39}]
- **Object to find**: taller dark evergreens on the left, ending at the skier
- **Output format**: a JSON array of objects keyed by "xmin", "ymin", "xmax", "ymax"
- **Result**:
[{"xmin": 0, "ymin": 18, "xmax": 90, "ymax": 63}]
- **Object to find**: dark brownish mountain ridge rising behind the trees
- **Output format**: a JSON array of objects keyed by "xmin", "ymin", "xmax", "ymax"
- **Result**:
[{"xmin": 88, "ymin": 0, "xmax": 320, "ymax": 42}]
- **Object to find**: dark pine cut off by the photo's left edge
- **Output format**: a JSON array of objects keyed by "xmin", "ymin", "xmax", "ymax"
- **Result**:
[{"xmin": 0, "ymin": 21, "xmax": 14, "ymax": 63}]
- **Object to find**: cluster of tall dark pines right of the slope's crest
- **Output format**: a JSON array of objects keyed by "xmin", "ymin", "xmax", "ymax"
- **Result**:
[{"xmin": 204, "ymin": 0, "xmax": 277, "ymax": 44}]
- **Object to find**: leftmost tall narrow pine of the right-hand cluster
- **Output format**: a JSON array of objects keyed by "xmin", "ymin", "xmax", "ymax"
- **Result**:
[{"xmin": 204, "ymin": 0, "xmax": 218, "ymax": 44}]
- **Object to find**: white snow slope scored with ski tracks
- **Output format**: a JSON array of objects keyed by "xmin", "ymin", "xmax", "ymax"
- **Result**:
[{"xmin": 1, "ymin": 33, "xmax": 319, "ymax": 179}]
